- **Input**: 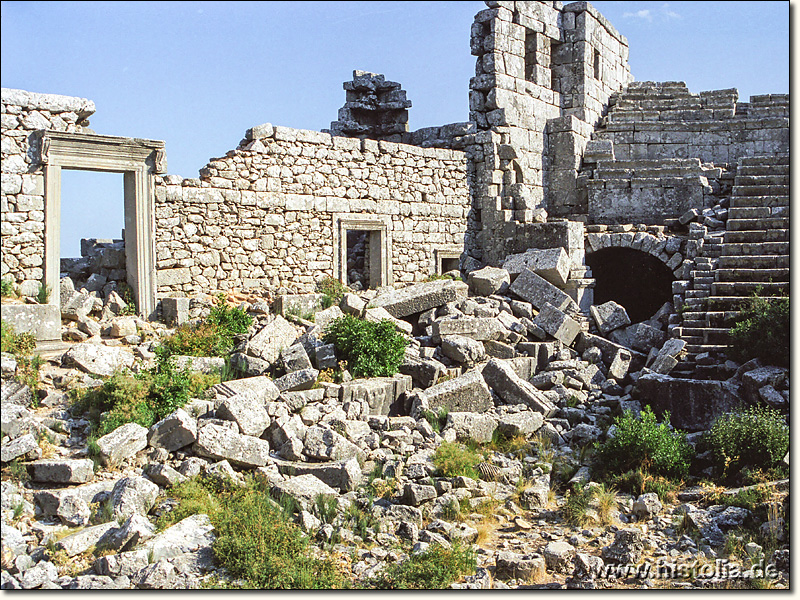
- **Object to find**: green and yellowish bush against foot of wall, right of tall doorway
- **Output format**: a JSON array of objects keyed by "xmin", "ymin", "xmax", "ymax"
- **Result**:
[{"xmin": 163, "ymin": 294, "xmax": 253, "ymax": 356}]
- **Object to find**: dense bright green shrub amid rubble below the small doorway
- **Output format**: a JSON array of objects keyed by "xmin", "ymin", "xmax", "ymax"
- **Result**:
[{"xmin": 323, "ymin": 315, "xmax": 407, "ymax": 377}]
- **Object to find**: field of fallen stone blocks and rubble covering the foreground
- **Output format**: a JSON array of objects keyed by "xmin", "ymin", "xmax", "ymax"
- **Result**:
[{"xmin": 2, "ymin": 260, "xmax": 789, "ymax": 589}]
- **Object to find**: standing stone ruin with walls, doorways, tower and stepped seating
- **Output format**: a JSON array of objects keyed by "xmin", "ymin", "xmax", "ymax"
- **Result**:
[{"xmin": 2, "ymin": 0, "xmax": 789, "ymax": 376}]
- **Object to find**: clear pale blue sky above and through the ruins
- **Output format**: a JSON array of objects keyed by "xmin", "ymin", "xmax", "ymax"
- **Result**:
[{"xmin": 0, "ymin": 1, "xmax": 789, "ymax": 256}]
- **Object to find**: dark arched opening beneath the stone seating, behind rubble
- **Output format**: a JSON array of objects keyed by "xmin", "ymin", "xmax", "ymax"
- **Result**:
[{"xmin": 586, "ymin": 248, "xmax": 675, "ymax": 323}]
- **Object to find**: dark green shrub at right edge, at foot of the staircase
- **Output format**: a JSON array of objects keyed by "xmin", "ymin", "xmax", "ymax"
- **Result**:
[{"xmin": 730, "ymin": 295, "xmax": 790, "ymax": 367}]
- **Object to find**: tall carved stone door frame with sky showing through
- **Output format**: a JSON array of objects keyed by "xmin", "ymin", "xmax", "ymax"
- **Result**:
[{"xmin": 40, "ymin": 131, "xmax": 166, "ymax": 318}]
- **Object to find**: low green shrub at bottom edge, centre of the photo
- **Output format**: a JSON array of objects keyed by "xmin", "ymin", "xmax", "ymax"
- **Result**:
[{"xmin": 370, "ymin": 544, "xmax": 477, "ymax": 590}]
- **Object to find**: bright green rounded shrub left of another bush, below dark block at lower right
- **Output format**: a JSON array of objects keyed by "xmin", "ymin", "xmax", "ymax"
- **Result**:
[{"xmin": 594, "ymin": 407, "xmax": 694, "ymax": 477}]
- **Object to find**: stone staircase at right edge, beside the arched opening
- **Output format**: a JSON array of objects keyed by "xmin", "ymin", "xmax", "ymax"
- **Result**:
[{"xmin": 673, "ymin": 155, "xmax": 789, "ymax": 378}]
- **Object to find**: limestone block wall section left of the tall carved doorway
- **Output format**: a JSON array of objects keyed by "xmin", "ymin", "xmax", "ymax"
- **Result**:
[{"xmin": 0, "ymin": 88, "xmax": 95, "ymax": 294}]
